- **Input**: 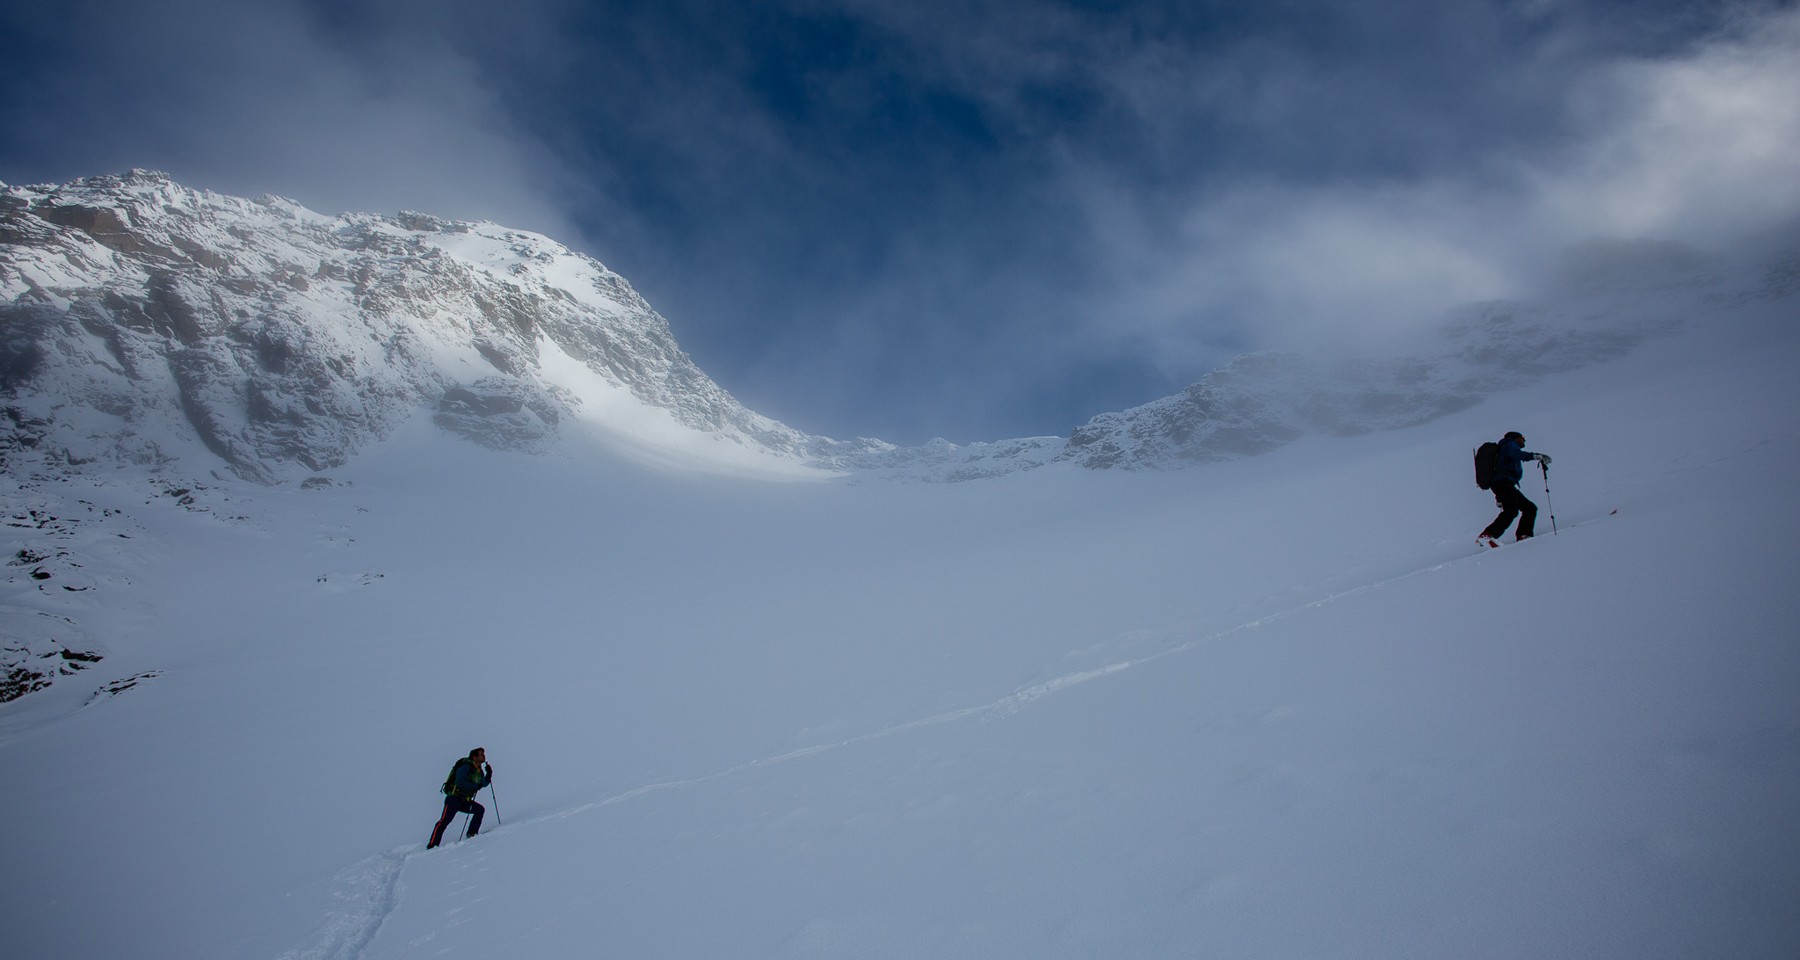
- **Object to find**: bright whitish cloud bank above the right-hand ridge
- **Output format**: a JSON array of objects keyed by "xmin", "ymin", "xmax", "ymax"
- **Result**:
[{"xmin": 1069, "ymin": 11, "xmax": 1800, "ymax": 367}]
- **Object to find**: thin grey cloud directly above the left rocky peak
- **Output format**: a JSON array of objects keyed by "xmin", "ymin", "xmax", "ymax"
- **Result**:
[{"xmin": 4, "ymin": 0, "xmax": 571, "ymax": 236}]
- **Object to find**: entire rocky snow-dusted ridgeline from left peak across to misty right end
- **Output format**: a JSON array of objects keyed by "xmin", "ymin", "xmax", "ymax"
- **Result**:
[{"xmin": 10, "ymin": 171, "xmax": 1795, "ymax": 483}]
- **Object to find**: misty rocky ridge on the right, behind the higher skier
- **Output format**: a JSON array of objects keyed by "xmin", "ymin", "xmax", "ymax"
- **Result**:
[{"xmin": 1060, "ymin": 243, "xmax": 1764, "ymax": 468}]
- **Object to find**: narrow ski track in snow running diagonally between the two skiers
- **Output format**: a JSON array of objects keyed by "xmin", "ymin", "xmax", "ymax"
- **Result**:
[{"xmin": 295, "ymin": 510, "xmax": 1618, "ymax": 960}]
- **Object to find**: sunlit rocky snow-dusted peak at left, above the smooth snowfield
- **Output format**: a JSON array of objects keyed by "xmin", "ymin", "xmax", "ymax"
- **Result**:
[{"xmin": 0, "ymin": 171, "xmax": 880, "ymax": 483}]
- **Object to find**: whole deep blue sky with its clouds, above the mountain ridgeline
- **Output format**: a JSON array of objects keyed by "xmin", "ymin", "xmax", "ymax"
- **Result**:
[{"xmin": 0, "ymin": 0, "xmax": 1800, "ymax": 443}]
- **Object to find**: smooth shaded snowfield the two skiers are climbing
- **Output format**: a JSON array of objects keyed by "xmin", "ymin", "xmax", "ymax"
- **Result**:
[{"xmin": 0, "ymin": 232, "xmax": 1800, "ymax": 960}]
